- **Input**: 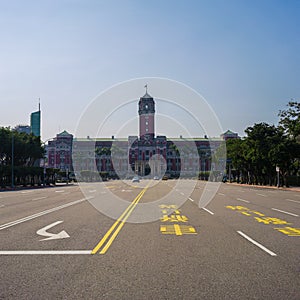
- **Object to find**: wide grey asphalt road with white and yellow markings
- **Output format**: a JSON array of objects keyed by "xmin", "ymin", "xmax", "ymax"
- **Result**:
[{"xmin": 0, "ymin": 180, "xmax": 300, "ymax": 299}]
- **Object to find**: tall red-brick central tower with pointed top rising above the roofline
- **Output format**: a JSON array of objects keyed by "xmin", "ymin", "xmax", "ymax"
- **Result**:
[{"xmin": 139, "ymin": 85, "xmax": 155, "ymax": 140}]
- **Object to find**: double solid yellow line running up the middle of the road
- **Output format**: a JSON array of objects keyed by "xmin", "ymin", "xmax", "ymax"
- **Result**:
[{"xmin": 92, "ymin": 184, "xmax": 149, "ymax": 254}]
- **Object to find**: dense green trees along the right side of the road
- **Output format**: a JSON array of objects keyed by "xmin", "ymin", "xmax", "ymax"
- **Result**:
[{"xmin": 226, "ymin": 101, "xmax": 300, "ymax": 186}]
